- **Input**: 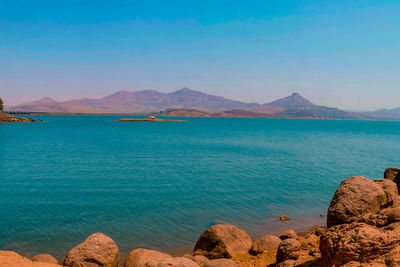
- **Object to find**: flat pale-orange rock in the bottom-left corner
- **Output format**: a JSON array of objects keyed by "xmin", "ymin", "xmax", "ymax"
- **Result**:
[{"xmin": 0, "ymin": 250, "xmax": 62, "ymax": 267}]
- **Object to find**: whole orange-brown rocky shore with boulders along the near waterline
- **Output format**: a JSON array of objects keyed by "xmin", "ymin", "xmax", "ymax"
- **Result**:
[{"xmin": 0, "ymin": 168, "xmax": 400, "ymax": 267}]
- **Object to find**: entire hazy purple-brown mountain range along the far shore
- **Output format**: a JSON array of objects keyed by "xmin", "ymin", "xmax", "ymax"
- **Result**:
[{"xmin": 8, "ymin": 88, "xmax": 390, "ymax": 119}]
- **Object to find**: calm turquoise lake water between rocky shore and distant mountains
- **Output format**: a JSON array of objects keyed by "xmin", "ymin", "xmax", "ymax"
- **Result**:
[{"xmin": 0, "ymin": 116, "xmax": 400, "ymax": 257}]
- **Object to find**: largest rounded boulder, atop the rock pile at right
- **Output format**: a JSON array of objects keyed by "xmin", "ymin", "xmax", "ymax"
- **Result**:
[{"xmin": 327, "ymin": 176, "xmax": 387, "ymax": 228}]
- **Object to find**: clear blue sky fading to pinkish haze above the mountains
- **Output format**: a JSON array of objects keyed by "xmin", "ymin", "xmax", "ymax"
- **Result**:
[{"xmin": 0, "ymin": 0, "xmax": 400, "ymax": 110}]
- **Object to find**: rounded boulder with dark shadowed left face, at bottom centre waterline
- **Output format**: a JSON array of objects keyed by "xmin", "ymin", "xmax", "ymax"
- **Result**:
[{"xmin": 193, "ymin": 224, "xmax": 253, "ymax": 259}]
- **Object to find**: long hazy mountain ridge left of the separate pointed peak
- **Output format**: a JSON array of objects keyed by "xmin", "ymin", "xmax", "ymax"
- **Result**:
[{"xmin": 10, "ymin": 88, "xmax": 258, "ymax": 113}]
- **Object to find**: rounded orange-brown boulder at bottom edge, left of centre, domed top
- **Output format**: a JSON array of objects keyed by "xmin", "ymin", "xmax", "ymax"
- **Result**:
[{"xmin": 64, "ymin": 233, "xmax": 119, "ymax": 267}]
